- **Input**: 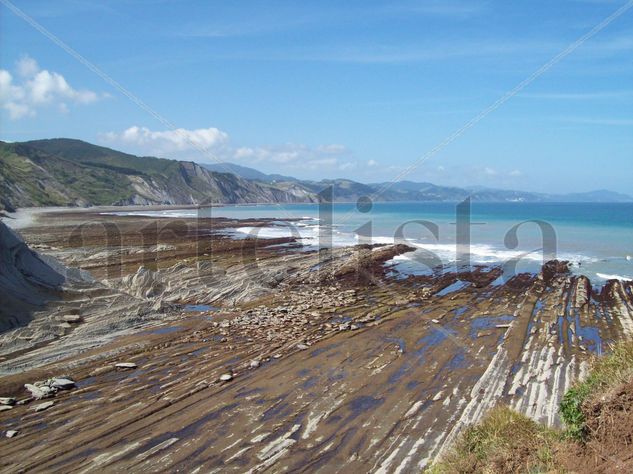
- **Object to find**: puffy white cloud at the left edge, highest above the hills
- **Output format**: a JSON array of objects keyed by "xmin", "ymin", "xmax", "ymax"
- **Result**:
[{"xmin": 0, "ymin": 56, "xmax": 100, "ymax": 120}]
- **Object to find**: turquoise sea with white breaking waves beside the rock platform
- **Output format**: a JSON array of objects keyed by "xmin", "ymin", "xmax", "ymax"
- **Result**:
[{"xmin": 114, "ymin": 201, "xmax": 633, "ymax": 284}]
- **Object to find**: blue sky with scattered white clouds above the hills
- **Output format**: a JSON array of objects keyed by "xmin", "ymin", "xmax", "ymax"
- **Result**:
[{"xmin": 0, "ymin": 0, "xmax": 633, "ymax": 194}]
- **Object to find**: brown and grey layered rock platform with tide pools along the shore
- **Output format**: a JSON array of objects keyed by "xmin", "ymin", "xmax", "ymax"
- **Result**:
[{"xmin": 0, "ymin": 210, "xmax": 633, "ymax": 472}]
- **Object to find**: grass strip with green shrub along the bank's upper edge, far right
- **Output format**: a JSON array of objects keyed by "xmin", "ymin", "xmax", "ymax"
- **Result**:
[{"xmin": 560, "ymin": 342, "xmax": 633, "ymax": 441}]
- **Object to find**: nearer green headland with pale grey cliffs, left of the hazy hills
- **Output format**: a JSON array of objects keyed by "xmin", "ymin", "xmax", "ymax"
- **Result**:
[{"xmin": 0, "ymin": 139, "xmax": 317, "ymax": 209}]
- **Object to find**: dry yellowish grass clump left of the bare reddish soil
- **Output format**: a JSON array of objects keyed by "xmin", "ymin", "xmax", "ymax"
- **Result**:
[{"xmin": 427, "ymin": 407, "xmax": 560, "ymax": 474}]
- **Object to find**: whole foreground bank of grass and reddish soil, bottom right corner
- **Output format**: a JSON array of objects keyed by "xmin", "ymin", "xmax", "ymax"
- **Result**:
[{"xmin": 427, "ymin": 342, "xmax": 633, "ymax": 474}]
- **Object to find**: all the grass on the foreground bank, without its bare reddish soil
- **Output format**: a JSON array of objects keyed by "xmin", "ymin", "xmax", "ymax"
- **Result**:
[{"xmin": 427, "ymin": 342, "xmax": 633, "ymax": 474}]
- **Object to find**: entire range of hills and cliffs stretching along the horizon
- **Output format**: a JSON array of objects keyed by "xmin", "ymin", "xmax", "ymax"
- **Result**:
[{"xmin": 0, "ymin": 138, "xmax": 633, "ymax": 210}]
